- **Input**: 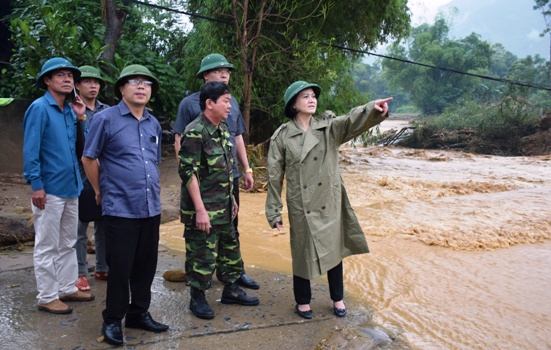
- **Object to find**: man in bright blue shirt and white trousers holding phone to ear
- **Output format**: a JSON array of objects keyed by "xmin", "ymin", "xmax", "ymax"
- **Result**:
[{"xmin": 23, "ymin": 57, "xmax": 94, "ymax": 314}]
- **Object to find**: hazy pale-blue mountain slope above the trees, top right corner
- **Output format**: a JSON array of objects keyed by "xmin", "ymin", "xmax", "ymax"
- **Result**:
[{"xmin": 439, "ymin": 0, "xmax": 550, "ymax": 60}]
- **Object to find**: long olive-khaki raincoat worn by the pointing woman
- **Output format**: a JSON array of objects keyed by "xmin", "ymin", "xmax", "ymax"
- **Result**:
[{"xmin": 266, "ymin": 102, "xmax": 385, "ymax": 279}]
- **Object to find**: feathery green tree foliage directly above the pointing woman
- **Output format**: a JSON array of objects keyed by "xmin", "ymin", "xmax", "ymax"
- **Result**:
[{"xmin": 179, "ymin": 0, "xmax": 409, "ymax": 142}]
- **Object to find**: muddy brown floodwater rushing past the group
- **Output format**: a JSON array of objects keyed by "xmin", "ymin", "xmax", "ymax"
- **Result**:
[{"xmin": 161, "ymin": 146, "xmax": 551, "ymax": 349}]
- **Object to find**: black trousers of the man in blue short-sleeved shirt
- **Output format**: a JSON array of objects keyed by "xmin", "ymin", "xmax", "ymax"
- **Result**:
[{"xmin": 103, "ymin": 215, "xmax": 161, "ymax": 323}]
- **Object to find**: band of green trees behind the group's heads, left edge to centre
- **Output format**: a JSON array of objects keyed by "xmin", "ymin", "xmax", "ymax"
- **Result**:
[{"xmin": 0, "ymin": 0, "xmax": 409, "ymax": 135}]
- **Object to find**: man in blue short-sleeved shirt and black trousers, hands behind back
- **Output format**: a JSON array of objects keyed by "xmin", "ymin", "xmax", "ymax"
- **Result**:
[{"xmin": 82, "ymin": 64, "xmax": 168, "ymax": 345}]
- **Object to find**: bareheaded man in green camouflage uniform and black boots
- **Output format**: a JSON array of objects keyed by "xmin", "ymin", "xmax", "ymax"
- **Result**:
[{"xmin": 178, "ymin": 82, "xmax": 260, "ymax": 319}]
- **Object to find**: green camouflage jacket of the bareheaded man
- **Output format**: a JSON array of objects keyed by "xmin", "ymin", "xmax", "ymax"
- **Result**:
[{"xmin": 178, "ymin": 114, "xmax": 234, "ymax": 225}]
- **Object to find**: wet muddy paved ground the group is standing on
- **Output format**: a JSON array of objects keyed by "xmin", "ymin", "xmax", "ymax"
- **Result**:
[{"xmin": 0, "ymin": 248, "xmax": 409, "ymax": 349}]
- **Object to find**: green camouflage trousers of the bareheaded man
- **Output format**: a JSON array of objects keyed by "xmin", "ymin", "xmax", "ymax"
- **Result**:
[{"xmin": 184, "ymin": 223, "xmax": 243, "ymax": 290}]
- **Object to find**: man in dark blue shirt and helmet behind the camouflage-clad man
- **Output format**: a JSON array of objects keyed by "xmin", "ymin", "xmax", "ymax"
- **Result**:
[{"xmin": 174, "ymin": 53, "xmax": 260, "ymax": 289}]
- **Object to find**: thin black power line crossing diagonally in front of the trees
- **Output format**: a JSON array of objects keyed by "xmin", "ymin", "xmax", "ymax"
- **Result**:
[{"xmin": 128, "ymin": 0, "xmax": 551, "ymax": 91}]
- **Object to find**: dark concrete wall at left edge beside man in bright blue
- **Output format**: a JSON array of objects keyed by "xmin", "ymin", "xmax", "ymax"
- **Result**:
[{"xmin": 0, "ymin": 100, "xmax": 32, "ymax": 174}]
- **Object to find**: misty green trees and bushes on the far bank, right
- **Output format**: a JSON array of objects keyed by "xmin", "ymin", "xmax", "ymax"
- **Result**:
[{"xmin": 376, "ymin": 12, "xmax": 551, "ymax": 154}]
